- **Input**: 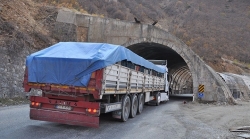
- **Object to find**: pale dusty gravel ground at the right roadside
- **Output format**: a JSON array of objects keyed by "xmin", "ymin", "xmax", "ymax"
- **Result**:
[{"xmin": 180, "ymin": 101, "xmax": 250, "ymax": 139}]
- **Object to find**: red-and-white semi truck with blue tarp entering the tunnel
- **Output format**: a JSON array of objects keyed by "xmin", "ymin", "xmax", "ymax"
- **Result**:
[{"xmin": 23, "ymin": 42, "xmax": 169, "ymax": 127}]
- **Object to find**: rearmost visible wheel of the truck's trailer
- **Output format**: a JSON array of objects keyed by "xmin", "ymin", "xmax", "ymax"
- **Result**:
[{"xmin": 121, "ymin": 95, "xmax": 131, "ymax": 122}]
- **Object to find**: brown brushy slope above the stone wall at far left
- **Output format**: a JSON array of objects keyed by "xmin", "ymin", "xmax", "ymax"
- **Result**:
[{"xmin": 0, "ymin": 0, "xmax": 57, "ymax": 49}]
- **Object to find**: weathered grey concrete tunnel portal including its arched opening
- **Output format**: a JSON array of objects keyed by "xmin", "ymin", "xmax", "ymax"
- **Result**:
[{"xmin": 56, "ymin": 9, "xmax": 235, "ymax": 103}]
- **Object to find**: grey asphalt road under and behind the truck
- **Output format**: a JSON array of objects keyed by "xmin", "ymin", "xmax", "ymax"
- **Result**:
[{"xmin": 0, "ymin": 101, "xmax": 226, "ymax": 139}]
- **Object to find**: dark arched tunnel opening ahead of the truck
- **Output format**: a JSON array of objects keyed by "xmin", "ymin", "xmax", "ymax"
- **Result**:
[{"xmin": 127, "ymin": 42, "xmax": 193, "ymax": 97}]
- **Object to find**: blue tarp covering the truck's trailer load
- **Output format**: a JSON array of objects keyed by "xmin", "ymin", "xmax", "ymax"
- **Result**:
[{"xmin": 26, "ymin": 42, "xmax": 166, "ymax": 86}]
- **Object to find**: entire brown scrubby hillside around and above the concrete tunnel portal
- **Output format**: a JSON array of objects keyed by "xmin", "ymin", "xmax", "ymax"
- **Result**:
[{"xmin": 0, "ymin": 0, "xmax": 250, "ymax": 98}]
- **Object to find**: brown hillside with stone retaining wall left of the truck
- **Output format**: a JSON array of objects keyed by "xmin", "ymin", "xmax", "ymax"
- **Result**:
[{"xmin": 0, "ymin": 0, "xmax": 58, "ymax": 98}]
